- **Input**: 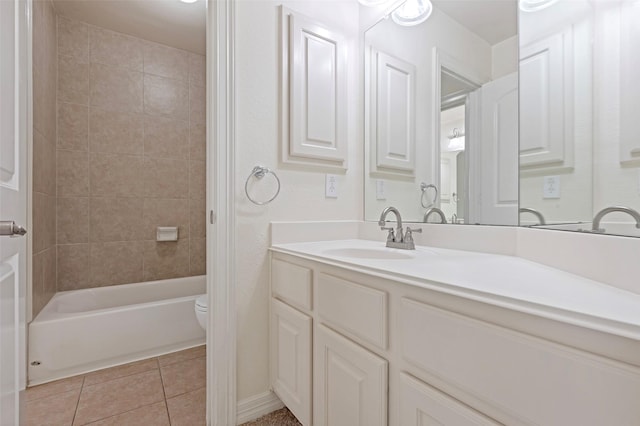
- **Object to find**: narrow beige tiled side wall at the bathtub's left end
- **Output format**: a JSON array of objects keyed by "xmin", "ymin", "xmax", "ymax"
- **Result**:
[{"xmin": 32, "ymin": 0, "xmax": 57, "ymax": 317}]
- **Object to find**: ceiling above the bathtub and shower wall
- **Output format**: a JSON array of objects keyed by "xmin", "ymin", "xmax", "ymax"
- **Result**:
[{"xmin": 54, "ymin": 0, "xmax": 206, "ymax": 55}]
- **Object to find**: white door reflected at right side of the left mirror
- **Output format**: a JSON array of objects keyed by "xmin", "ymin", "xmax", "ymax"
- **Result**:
[{"xmin": 478, "ymin": 73, "xmax": 518, "ymax": 225}]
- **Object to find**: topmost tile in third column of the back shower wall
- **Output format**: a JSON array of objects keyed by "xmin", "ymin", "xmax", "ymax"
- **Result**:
[{"xmin": 144, "ymin": 43, "xmax": 189, "ymax": 81}]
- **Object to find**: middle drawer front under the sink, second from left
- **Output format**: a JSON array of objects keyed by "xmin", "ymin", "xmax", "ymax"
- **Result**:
[{"xmin": 317, "ymin": 273, "xmax": 388, "ymax": 349}]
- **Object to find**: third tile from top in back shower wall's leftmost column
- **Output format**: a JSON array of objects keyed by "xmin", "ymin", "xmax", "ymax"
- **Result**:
[{"xmin": 58, "ymin": 102, "xmax": 89, "ymax": 151}]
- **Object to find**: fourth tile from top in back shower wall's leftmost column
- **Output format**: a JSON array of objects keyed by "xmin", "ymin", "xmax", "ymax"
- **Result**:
[{"xmin": 57, "ymin": 149, "xmax": 89, "ymax": 197}]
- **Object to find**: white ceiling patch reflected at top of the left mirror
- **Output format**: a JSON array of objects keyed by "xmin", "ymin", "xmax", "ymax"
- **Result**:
[{"xmin": 432, "ymin": 0, "xmax": 518, "ymax": 46}]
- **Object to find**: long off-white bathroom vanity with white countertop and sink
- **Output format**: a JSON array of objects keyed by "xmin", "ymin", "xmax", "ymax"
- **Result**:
[{"xmin": 270, "ymin": 240, "xmax": 640, "ymax": 426}]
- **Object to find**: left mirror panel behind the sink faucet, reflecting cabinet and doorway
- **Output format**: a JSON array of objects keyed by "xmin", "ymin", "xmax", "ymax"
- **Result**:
[{"xmin": 365, "ymin": 0, "xmax": 518, "ymax": 225}]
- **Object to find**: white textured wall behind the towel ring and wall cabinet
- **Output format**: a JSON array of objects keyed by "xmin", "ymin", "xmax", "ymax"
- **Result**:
[{"xmin": 235, "ymin": 1, "xmax": 363, "ymax": 400}]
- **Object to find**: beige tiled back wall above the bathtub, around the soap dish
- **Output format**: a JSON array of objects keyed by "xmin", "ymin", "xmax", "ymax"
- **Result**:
[{"xmin": 56, "ymin": 17, "xmax": 205, "ymax": 291}]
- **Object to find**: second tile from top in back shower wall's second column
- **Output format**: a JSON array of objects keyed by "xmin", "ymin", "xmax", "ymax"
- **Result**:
[{"xmin": 89, "ymin": 63, "xmax": 142, "ymax": 112}]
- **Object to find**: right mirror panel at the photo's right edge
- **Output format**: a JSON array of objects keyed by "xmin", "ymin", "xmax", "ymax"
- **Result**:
[{"xmin": 519, "ymin": 0, "xmax": 640, "ymax": 236}]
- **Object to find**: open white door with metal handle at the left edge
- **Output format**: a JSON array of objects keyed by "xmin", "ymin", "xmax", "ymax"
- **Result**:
[{"xmin": 0, "ymin": 0, "xmax": 28, "ymax": 425}]
